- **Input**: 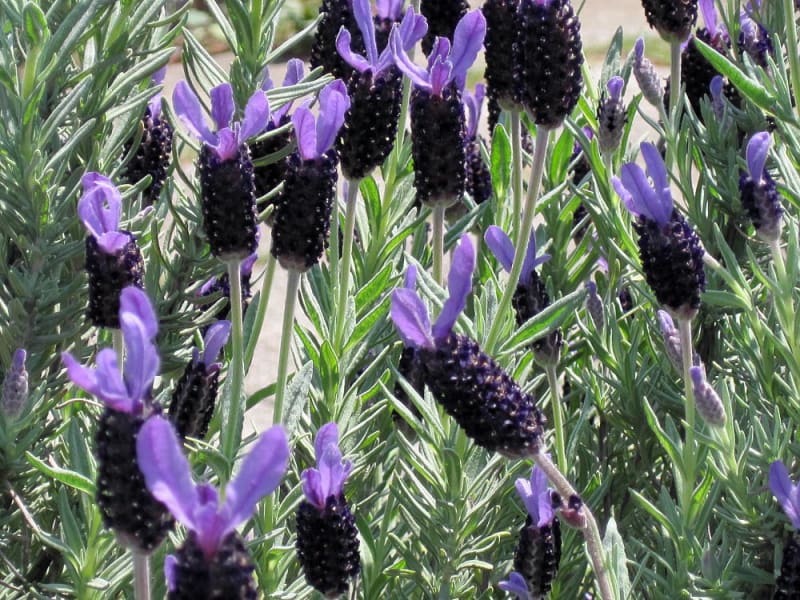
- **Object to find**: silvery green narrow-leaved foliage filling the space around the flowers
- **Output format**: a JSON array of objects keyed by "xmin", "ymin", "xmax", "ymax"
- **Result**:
[{"xmin": 0, "ymin": 0, "xmax": 800, "ymax": 600}]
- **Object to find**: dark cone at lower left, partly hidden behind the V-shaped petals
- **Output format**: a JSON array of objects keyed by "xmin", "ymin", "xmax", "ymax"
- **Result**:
[{"xmin": 95, "ymin": 408, "xmax": 175, "ymax": 553}]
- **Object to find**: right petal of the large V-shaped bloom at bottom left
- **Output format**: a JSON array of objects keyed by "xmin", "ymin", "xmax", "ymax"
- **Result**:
[{"xmin": 221, "ymin": 425, "xmax": 289, "ymax": 535}]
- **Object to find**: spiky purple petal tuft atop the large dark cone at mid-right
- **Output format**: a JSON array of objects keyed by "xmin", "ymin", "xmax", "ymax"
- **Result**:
[{"xmin": 611, "ymin": 142, "xmax": 672, "ymax": 226}]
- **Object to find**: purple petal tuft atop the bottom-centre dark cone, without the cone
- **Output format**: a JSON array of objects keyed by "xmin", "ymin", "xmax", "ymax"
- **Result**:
[{"xmin": 300, "ymin": 423, "xmax": 353, "ymax": 510}]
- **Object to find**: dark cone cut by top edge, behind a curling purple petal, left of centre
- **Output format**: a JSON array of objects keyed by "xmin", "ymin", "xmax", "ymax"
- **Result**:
[{"xmin": 309, "ymin": 0, "xmax": 366, "ymax": 81}]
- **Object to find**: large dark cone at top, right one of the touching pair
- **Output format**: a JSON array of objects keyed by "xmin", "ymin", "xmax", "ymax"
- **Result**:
[{"xmin": 514, "ymin": 0, "xmax": 583, "ymax": 128}]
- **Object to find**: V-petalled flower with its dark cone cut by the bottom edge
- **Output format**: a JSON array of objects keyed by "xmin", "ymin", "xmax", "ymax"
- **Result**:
[{"xmin": 136, "ymin": 417, "xmax": 289, "ymax": 600}]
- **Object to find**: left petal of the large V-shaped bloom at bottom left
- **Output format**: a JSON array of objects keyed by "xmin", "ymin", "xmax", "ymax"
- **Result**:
[{"xmin": 136, "ymin": 417, "xmax": 198, "ymax": 531}]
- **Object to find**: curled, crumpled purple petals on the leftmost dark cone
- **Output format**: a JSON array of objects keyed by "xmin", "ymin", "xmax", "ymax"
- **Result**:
[{"xmin": 78, "ymin": 176, "xmax": 130, "ymax": 254}]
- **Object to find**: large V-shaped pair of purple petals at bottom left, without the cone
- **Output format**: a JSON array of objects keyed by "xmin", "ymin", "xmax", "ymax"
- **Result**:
[{"xmin": 136, "ymin": 416, "xmax": 289, "ymax": 560}]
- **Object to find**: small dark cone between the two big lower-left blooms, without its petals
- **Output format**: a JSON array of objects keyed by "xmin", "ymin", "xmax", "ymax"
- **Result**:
[{"xmin": 169, "ymin": 361, "xmax": 219, "ymax": 440}]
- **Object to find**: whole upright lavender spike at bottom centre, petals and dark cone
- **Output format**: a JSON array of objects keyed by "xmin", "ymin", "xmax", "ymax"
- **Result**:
[{"xmin": 296, "ymin": 423, "xmax": 361, "ymax": 598}]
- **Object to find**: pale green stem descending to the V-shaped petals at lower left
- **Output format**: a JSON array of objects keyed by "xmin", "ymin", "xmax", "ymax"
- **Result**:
[{"xmin": 222, "ymin": 258, "xmax": 244, "ymax": 464}]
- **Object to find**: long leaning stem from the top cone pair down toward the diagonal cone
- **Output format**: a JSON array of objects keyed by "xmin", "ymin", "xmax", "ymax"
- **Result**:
[{"xmin": 485, "ymin": 127, "xmax": 550, "ymax": 355}]
